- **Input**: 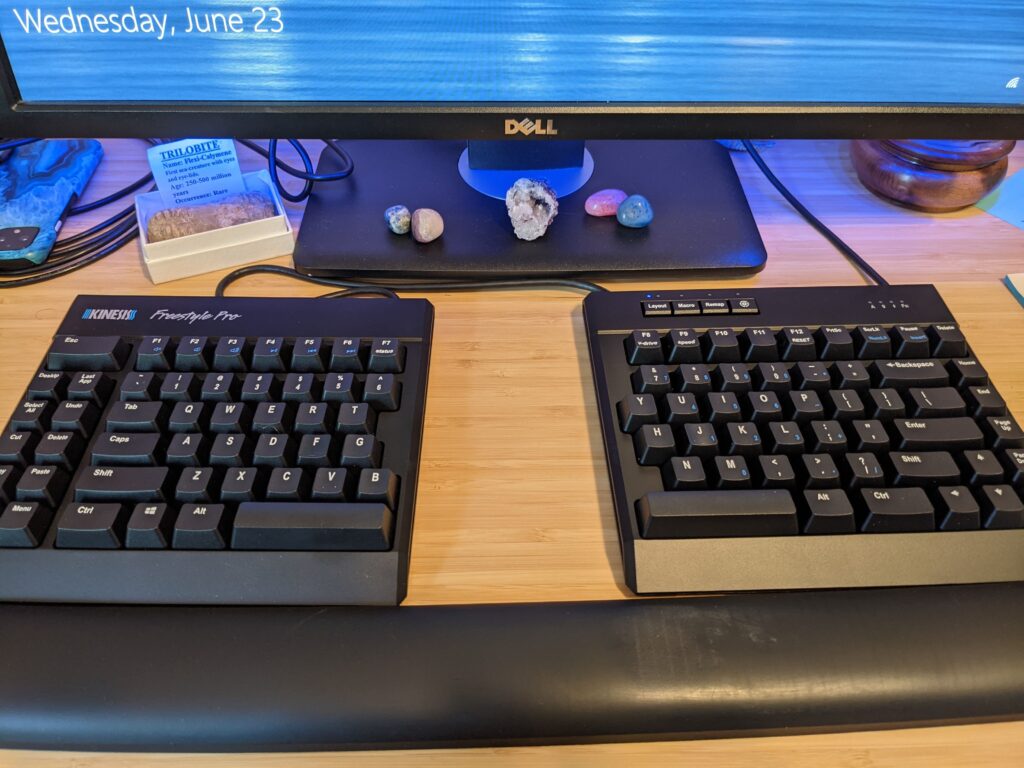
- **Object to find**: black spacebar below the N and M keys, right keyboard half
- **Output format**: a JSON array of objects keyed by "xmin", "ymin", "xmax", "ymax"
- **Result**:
[{"xmin": 637, "ymin": 490, "xmax": 798, "ymax": 539}]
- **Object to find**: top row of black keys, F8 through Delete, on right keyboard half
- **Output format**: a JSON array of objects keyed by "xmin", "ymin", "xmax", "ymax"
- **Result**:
[{"xmin": 626, "ymin": 323, "xmax": 967, "ymax": 366}]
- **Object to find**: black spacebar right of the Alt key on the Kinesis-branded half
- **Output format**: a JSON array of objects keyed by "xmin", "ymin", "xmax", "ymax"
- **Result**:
[{"xmin": 231, "ymin": 502, "xmax": 394, "ymax": 551}]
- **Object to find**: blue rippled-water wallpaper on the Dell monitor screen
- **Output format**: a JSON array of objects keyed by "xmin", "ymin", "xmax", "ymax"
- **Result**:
[{"xmin": 0, "ymin": 0, "xmax": 1024, "ymax": 104}]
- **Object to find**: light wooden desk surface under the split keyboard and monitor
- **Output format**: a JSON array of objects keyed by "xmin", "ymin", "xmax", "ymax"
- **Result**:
[{"xmin": 0, "ymin": 140, "xmax": 1024, "ymax": 766}]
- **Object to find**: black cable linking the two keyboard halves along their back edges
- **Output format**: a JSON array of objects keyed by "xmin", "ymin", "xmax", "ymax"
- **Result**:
[{"xmin": 214, "ymin": 264, "xmax": 607, "ymax": 298}]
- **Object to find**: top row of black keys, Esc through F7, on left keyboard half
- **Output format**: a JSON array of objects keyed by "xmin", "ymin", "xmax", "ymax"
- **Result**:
[{"xmin": 46, "ymin": 335, "xmax": 406, "ymax": 373}]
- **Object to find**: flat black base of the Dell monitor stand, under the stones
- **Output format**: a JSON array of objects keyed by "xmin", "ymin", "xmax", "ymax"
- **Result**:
[{"xmin": 295, "ymin": 140, "xmax": 766, "ymax": 280}]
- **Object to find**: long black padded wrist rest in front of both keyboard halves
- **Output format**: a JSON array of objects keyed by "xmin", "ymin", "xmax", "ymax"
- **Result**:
[{"xmin": 0, "ymin": 584, "xmax": 1024, "ymax": 751}]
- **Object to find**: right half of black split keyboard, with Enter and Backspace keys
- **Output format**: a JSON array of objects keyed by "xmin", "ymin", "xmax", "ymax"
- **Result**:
[{"xmin": 584, "ymin": 286, "xmax": 1024, "ymax": 594}]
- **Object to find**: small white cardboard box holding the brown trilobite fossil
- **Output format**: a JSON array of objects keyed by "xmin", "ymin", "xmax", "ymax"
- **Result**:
[{"xmin": 135, "ymin": 171, "xmax": 295, "ymax": 283}]
